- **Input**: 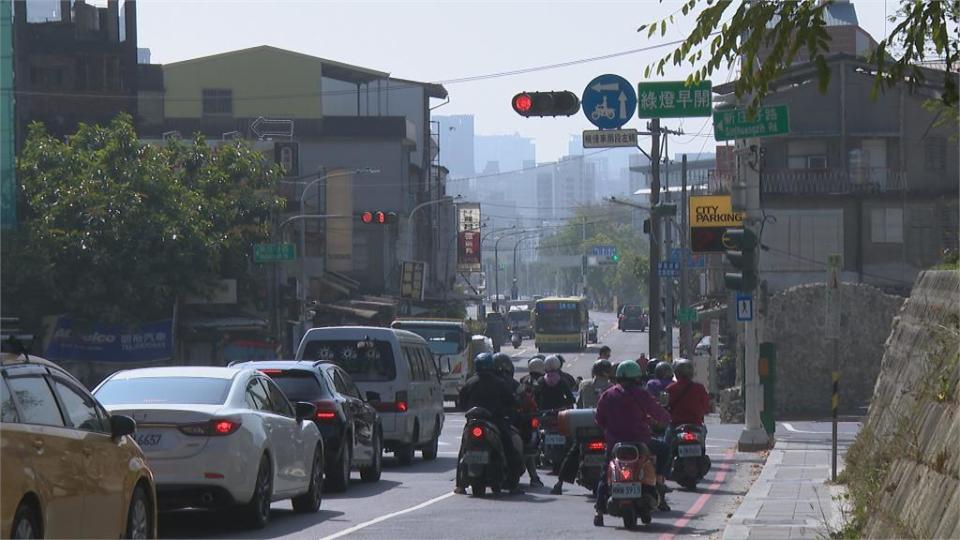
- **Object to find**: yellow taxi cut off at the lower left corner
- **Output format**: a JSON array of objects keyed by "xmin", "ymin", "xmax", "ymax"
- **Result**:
[{"xmin": 0, "ymin": 353, "xmax": 157, "ymax": 538}]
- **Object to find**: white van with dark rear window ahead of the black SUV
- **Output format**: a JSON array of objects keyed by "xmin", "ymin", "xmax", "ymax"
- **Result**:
[{"xmin": 296, "ymin": 326, "xmax": 443, "ymax": 463}]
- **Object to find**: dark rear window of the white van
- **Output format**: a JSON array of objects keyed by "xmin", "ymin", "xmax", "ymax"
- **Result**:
[{"xmin": 303, "ymin": 339, "xmax": 397, "ymax": 382}]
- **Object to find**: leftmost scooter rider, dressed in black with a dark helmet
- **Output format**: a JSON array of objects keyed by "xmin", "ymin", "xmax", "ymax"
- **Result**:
[{"xmin": 454, "ymin": 352, "xmax": 523, "ymax": 494}]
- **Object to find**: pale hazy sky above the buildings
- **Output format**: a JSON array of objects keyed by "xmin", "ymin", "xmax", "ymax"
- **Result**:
[{"xmin": 138, "ymin": 0, "xmax": 899, "ymax": 165}]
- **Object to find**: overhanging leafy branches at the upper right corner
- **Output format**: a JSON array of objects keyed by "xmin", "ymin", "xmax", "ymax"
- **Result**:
[{"xmin": 638, "ymin": 0, "xmax": 960, "ymax": 110}]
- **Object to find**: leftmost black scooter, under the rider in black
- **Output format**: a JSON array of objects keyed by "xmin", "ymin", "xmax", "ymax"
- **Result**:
[{"xmin": 457, "ymin": 407, "xmax": 522, "ymax": 497}]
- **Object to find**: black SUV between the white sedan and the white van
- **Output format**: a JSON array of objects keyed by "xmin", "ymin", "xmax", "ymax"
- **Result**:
[{"xmin": 234, "ymin": 360, "xmax": 383, "ymax": 491}]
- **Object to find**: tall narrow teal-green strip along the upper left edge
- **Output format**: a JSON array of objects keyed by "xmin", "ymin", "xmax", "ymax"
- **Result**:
[{"xmin": 0, "ymin": 2, "xmax": 15, "ymax": 229}]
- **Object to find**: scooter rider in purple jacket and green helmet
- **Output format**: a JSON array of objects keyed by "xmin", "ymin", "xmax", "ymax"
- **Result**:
[{"xmin": 593, "ymin": 360, "xmax": 670, "ymax": 527}]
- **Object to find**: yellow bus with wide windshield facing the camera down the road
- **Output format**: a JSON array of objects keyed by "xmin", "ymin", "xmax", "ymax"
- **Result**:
[{"xmin": 533, "ymin": 297, "xmax": 590, "ymax": 352}]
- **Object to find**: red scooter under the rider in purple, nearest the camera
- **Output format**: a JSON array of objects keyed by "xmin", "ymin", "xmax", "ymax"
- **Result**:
[{"xmin": 606, "ymin": 443, "xmax": 659, "ymax": 530}]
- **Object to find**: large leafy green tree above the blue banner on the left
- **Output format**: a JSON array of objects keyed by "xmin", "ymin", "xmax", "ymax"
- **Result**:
[{"xmin": 2, "ymin": 115, "xmax": 280, "ymax": 322}]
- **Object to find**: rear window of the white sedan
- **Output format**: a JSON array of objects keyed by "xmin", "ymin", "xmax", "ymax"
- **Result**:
[{"xmin": 96, "ymin": 377, "xmax": 231, "ymax": 405}]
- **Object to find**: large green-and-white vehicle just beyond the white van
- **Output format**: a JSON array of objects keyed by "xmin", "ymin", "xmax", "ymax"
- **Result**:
[{"xmin": 390, "ymin": 318, "xmax": 493, "ymax": 401}]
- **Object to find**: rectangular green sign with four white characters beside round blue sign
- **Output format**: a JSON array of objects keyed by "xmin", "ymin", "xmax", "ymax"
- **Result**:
[{"xmin": 637, "ymin": 81, "xmax": 713, "ymax": 118}]
